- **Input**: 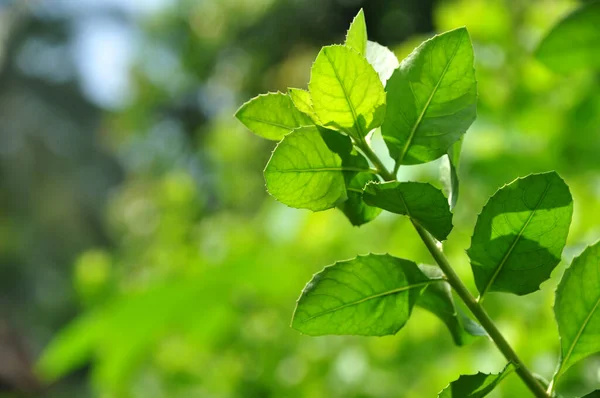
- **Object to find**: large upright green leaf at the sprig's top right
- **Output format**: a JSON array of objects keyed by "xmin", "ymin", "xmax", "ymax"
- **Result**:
[{"xmin": 381, "ymin": 28, "xmax": 477, "ymax": 165}]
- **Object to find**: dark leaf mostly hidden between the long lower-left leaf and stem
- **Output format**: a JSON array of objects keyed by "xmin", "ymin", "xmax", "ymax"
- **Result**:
[{"xmin": 417, "ymin": 265, "xmax": 487, "ymax": 346}]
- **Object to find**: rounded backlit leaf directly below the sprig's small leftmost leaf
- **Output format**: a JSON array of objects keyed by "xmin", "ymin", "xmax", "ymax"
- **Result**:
[{"xmin": 265, "ymin": 126, "xmax": 369, "ymax": 211}]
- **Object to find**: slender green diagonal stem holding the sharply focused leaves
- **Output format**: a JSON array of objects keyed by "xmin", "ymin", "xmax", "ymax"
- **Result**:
[{"xmin": 358, "ymin": 142, "xmax": 550, "ymax": 398}]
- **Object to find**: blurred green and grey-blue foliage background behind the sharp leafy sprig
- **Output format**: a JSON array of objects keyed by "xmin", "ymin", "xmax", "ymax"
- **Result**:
[{"xmin": 0, "ymin": 0, "xmax": 600, "ymax": 398}]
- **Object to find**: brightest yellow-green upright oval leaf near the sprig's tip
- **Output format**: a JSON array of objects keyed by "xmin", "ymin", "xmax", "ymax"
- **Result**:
[{"xmin": 308, "ymin": 46, "xmax": 385, "ymax": 140}]
